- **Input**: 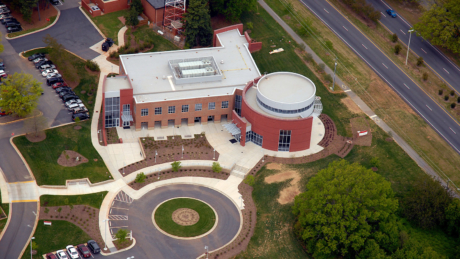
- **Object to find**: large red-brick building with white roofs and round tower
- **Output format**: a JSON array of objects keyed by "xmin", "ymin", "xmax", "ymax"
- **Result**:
[{"xmin": 102, "ymin": 24, "xmax": 322, "ymax": 151}]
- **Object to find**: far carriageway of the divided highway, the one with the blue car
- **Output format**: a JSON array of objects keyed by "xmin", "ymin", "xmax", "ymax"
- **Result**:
[{"xmin": 367, "ymin": 0, "xmax": 460, "ymax": 94}]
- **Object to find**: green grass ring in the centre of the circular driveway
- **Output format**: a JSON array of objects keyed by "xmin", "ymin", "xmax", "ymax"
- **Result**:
[{"xmin": 155, "ymin": 198, "xmax": 216, "ymax": 237}]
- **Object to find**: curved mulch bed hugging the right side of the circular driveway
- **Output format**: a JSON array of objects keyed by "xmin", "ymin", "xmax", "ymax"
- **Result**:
[{"xmin": 200, "ymin": 182, "xmax": 257, "ymax": 259}]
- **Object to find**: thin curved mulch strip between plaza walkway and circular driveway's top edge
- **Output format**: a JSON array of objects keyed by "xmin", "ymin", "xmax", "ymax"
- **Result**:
[{"xmin": 129, "ymin": 167, "xmax": 230, "ymax": 190}]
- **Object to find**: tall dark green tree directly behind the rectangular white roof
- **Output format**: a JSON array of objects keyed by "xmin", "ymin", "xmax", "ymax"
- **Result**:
[{"xmin": 183, "ymin": 0, "xmax": 213, "ymax": 47}]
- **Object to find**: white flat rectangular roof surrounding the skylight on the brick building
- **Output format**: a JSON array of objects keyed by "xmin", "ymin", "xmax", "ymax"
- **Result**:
[{"xmin": 120, "ymin": 29, "xmax": 260, "ymax": 102}]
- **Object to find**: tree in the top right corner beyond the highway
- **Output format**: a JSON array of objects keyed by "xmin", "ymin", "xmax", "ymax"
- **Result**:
[{"xmin": 414, "ymin": 0, "xmax": 460, "ymax": 53}]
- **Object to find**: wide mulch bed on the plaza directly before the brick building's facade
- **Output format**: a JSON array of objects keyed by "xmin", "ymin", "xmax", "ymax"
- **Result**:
[{"xmin": 118, "ymin": 134, "xmax": 219, "ymax": 176}]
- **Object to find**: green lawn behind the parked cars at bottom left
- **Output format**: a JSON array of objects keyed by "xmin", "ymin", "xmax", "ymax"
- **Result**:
[{"xmin": 22, "ymin": 220, "xmax": 91, "ymax": 259}]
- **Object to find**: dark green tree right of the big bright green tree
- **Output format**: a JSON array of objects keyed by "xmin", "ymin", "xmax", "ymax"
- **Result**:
[{"xmin": 401, "ymin": 175, "xmax": 452, "ymax": 229}]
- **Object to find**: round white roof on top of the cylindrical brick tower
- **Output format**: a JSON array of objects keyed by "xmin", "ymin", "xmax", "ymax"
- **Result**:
[{"xmin": 257, "ymin": 72, "xmax": 316, "ymax": 103}]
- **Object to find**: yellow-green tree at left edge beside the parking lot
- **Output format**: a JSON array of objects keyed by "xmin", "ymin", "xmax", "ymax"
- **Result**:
[{"xmin": 0, "ymin": 73, "xmax": 43, "ymax": 117}]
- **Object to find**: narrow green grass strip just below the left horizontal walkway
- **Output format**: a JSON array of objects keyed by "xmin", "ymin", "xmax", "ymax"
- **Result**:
[{"xmin": 40, "ymin": 191, "xmax": 107, "ymax": 209}]
